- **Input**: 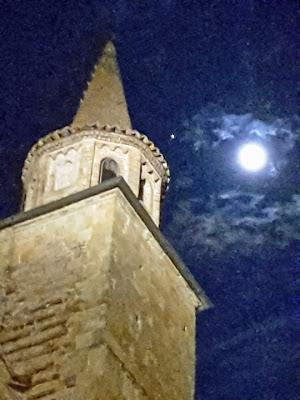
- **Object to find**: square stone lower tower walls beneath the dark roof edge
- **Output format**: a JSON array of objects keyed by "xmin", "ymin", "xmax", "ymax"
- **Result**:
[{"xmin": 0, "ymin": 189, "xmax": 198, "ymax": 400}]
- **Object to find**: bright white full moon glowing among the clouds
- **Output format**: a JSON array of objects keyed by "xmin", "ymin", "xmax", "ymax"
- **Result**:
[{"xmin": 238, "ymin": 143, "xmax": 268, "ymax": 172}]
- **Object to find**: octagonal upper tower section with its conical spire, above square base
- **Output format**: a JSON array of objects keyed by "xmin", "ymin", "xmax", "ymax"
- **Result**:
[{"xmin": 22, "ymin": 42, "xmax": 170, "ymax": 225}]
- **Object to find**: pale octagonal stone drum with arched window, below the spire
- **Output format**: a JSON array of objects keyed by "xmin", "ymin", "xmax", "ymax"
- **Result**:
[{"xmin": 24, "ymin": 127, "xmax": 165, "ymax": 225}]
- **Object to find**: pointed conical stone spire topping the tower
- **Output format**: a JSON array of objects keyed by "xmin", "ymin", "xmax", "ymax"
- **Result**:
[{"xmin": 72, "ymin": 41, "xmax": 131, "ymax": 129}]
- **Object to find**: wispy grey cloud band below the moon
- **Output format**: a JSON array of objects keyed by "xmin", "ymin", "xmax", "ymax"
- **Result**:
[{"xmin": 168, "ymin": 191, "xmax": 300, "ymax": 259}]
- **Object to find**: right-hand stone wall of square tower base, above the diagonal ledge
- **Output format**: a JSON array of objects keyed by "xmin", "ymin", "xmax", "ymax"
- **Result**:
[{"xmin": 105, "ymin": 192, "xmax": 197, "ymax": 400}]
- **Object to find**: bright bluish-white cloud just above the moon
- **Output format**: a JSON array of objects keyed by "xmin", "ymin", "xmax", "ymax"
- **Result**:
[{"xmin": 180, "ymin": 106, "xmax": 300, "ymax": 175}]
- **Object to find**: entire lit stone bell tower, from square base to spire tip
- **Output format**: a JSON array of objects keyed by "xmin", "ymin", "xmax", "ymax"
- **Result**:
[{"xmin": 0, "ymin": 42, "xmax": 209, "ymax": 400}]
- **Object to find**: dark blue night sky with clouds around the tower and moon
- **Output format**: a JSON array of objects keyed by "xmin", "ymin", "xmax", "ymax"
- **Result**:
[{"xmin": 0, "ymin": 0, "xmax": 300, "ymax": 400}]
